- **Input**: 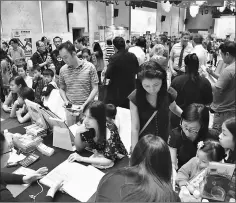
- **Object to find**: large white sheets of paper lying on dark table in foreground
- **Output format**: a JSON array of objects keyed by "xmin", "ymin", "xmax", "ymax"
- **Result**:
[{"xmin": 40, "ymin": 161, "xmax": 104, "ymax": 202}]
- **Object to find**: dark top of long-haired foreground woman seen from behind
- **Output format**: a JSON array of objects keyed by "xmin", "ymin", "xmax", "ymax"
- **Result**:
[{"xmin": 95, "ymin": 173, "xmax": 180, "ymax": 202}]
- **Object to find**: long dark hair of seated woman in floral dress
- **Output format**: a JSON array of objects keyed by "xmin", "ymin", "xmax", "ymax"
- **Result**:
[{"xmin": 83, "ymin": 101, "xmax": 106, "ymax": 143}]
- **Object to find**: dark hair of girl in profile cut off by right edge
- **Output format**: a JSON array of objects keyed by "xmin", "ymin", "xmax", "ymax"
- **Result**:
[{"xmin": 224, "ymin": 117, "xmax": 236, "ymax": 163}]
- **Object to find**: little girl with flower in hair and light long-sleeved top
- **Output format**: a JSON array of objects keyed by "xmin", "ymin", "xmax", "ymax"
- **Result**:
[{"xmin": 176, "ymin": 140, "xmax": 225, "ymax": 190}]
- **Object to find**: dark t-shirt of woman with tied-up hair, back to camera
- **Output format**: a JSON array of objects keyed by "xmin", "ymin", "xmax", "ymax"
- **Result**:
[{"xmin": 171, "ymin": 75, "xmax": 213, "ymax": 108}]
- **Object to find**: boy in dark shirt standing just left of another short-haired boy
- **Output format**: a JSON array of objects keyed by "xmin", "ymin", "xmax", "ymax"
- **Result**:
[{"xmin": 32, "ymin": 66, "xmax": 44, "ymax": 105}]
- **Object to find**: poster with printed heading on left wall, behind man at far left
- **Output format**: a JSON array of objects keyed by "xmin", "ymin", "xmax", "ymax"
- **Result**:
[{"xmin": 12, "ymin": 29, "xmax": 33, "ymax": 57}]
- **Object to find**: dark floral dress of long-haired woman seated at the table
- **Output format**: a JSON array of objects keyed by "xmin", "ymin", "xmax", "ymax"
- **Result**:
[{"xmin": 81, "ymin": 121, "xmax": 128, "ymax": 161}]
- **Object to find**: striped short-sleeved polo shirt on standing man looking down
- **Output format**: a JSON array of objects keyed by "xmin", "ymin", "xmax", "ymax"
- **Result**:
[{"xmin": 59, "ymin": 61, "xmax": 98, "ymax": 105}]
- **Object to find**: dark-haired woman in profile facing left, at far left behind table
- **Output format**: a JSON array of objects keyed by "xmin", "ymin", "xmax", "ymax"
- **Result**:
[{"xmin": 2, "ymin": 76, "xmax": 27, "ymax": 112}]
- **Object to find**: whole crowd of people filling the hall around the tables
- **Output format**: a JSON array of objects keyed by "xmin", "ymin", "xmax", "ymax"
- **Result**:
[{"xmin": 0, "ymin": 31, "xmax": 236, "ymax": 202}]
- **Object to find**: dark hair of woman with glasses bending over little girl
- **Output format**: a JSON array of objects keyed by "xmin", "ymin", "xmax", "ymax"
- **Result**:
[{"xmin": 181, "ymin": 103, "xmax": 209, "ymax": 144}]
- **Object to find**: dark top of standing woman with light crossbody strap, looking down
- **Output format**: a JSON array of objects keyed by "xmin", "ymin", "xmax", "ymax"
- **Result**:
[{"xmin": 128, "ymin": 88, "xmax": 177, "ymax": 141}]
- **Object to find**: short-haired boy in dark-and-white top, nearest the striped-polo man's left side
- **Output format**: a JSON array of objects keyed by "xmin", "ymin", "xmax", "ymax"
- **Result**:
[{"xmin": 42, "ymin": 69, "xmax": 58, "ymax": 100}]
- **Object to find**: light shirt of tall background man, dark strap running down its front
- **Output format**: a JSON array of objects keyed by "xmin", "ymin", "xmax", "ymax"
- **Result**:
[{"xmin": 170, "ymin": 42, "xmax": 193, "ymax": 72}]
